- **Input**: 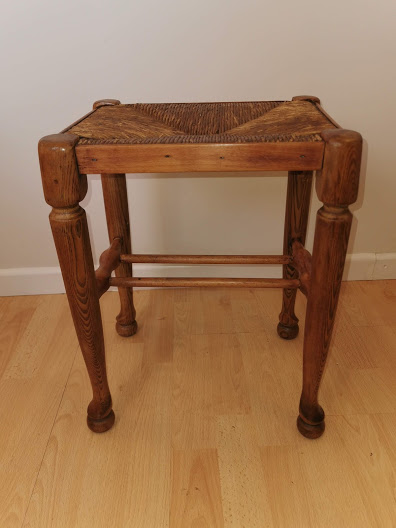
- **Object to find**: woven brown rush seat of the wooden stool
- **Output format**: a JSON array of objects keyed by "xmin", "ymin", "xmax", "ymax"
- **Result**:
[{"xmin": 68, "ymin": 100, "xmax": 335, "ymax": 145}]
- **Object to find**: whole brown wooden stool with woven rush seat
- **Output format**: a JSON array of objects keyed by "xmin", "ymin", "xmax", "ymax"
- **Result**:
[{"xmin": 39, "ymin": 96, "xmax": 362, "ymax": 438}]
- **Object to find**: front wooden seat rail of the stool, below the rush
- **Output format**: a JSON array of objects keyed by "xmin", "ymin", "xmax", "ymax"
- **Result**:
[{"xmin": 76, "ymin": 142, "xmax": 324, "ymax": 174}]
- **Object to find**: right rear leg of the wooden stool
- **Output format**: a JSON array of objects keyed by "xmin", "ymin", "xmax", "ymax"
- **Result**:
[{"xmin": 277, "ymin": 171, "xmax": 312, "ymax": 339}]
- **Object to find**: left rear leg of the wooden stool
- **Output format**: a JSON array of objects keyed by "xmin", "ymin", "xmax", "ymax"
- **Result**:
[{"xmin": 102, "ymin": 174, "xmax": 137, "ymax": 337}]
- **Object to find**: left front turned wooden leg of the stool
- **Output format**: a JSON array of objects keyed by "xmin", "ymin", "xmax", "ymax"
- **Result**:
[{"xmin": 39, "ymin": 134, "xmax": 114, "ymax": 433}]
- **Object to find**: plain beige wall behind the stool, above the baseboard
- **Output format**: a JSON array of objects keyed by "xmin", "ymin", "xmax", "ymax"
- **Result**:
[{"xmin": 0, "ymin": 0, "xmax": 396, "ymax": 292}]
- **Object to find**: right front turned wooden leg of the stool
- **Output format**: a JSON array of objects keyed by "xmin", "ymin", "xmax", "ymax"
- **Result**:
[{"xmin": 297, "ymin": 130, "xmax": 362, "ymax": 438}]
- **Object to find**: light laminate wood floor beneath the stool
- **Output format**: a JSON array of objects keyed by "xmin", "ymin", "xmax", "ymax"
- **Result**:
[{"xmin": 0, "ymin": 281, "xmax": 396, "ymax": 528}]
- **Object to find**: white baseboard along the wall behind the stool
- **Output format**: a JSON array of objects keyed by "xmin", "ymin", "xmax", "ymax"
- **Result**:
[{"xmin": 0, "ymin": 253, "xmax": 396, "ymax": 296}]
